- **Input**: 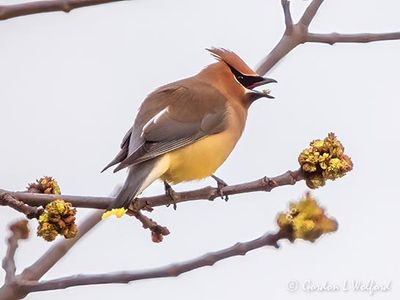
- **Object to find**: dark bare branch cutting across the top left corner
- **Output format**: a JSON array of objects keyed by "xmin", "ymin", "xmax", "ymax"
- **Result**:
[{"xmin": 0, "ymin": 0, "xmax": 128, "ymax": 20}]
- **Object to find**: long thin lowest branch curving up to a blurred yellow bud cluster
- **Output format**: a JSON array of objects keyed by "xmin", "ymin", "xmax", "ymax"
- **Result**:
[{"xmin": 21, "ymin": 231, "xmax": 288, "ymax": 292}]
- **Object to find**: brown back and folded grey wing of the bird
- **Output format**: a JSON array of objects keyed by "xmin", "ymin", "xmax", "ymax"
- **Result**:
[{"xmin": 101, "ymin": 79, "xmax": 227, "ymax": 172}]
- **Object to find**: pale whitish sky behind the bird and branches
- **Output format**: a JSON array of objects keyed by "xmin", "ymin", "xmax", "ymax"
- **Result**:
[{"xmin": 0, "ymin": 0, "xmax": 400, "ymax": 300}]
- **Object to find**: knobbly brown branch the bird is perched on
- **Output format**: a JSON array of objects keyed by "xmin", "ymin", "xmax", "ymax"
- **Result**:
[{"xmin": 3, "ymin": 169, "xmax": 304, "ymax": 211}]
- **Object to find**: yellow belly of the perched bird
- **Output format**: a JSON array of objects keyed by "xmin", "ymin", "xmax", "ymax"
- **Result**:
[{"xmin": 161, "ymin": 131, "xmax": 239, "ymax": 184}]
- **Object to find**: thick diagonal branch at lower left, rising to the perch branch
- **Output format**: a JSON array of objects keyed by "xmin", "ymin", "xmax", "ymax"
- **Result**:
[{"xmin": 18, "ymin": 210, "xmax": 103, "ymax": 280}]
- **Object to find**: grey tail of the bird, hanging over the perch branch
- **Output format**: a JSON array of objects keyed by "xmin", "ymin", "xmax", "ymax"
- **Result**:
[{"xmin": 107, "ymin": 160, "xmax": 157, "ymax": 210}]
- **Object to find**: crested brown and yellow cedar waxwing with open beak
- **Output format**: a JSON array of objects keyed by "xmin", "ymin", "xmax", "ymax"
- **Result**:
[{"xmin": 103, "ymin": 48, "xmax": 276, "ymax": 210}]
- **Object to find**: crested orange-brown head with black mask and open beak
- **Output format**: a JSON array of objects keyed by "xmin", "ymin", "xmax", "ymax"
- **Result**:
[{"xmin": 207, "ymin": 48, "xmax": 277, "ymax": 105}]
